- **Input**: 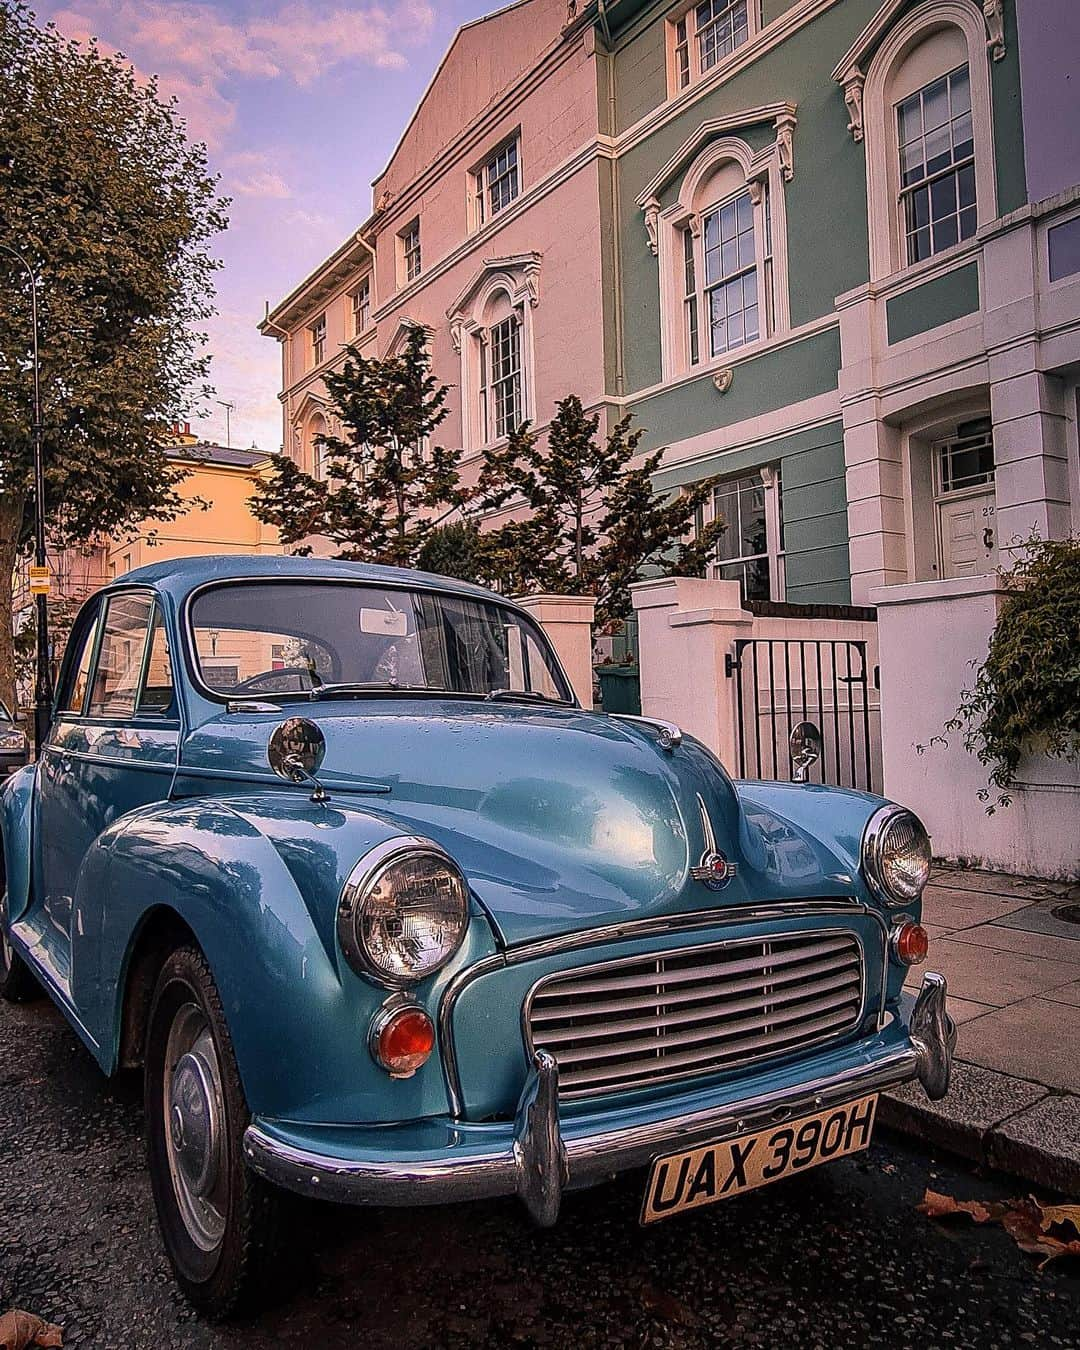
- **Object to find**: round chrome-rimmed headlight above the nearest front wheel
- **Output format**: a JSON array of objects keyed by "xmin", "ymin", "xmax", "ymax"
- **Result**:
[{"xmin": 338, "ymin": 837, "xmax": 468, "ymax": 988}]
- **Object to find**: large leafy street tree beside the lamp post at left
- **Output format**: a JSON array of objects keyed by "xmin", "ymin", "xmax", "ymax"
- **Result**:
[{"xmin": 0, "ymin": 0, "xmax": 227, "ymax": 701}]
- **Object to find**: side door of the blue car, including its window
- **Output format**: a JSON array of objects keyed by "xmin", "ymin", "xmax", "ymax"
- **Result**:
[{"xmin": 28, "ymin": 587, "xmax": 180, "ymax": 996}]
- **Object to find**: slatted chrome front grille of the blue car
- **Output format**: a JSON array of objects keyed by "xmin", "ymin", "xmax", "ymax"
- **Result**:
[{"xmin": 525, "ymin": 932, "xmax": 863, "ymax": 1098}]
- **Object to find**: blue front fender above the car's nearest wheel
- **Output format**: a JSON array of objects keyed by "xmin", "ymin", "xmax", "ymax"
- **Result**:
[{"xmin": 72, "ymin": 791, "xmax": 494, "ymax": 1123}]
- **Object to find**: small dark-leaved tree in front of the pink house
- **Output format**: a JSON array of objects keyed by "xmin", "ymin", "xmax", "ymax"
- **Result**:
[{"xmin": 251, "ymin": 327, "xmax": 466, "ymax": 567}]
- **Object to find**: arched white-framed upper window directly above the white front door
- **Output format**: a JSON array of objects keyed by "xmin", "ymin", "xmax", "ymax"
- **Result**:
[{"xmin": 845, "ymin": 0, "xmax": 996, "ymax": 279}]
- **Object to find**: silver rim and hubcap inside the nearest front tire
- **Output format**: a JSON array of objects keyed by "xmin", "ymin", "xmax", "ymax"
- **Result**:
[{"xmin": 165, "ymin": 1003, "xmax": 227, "ymax": 1251}]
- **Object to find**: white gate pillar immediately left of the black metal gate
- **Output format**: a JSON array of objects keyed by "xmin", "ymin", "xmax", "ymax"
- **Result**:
[{"xmin": 630, "ymin": 576, "xmax": 753, "ymax": 772}]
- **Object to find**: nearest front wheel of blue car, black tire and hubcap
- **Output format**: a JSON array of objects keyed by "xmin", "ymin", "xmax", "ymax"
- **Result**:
[{"xmin": 143, "ymin": 946, "xmax": 285, "ymax": 1319}]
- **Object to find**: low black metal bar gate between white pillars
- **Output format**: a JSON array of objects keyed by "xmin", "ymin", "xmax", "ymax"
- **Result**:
[{"xmin": 725, "ymin": 637, "xmax": 880, "ymax": 792}]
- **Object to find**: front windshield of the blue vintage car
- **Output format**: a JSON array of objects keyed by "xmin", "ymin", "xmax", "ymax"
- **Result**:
[{"xmin": 190, "ymin": 581, "xmax": 572, "ymax": 702}]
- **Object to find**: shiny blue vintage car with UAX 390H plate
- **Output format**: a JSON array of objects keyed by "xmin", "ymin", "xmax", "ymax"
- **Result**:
[{"xmin": 0, "ymin": 556, "xmax": 954, "ymax": 1315}]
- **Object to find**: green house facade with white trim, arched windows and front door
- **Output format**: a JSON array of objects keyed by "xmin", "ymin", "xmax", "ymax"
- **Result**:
[{"xmin": 578, "ymin": 0, "xmax": 1080, "ymax": 605}]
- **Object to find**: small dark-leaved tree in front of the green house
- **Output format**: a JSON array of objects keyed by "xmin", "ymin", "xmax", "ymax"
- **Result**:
[{"xmin": 479, "ymin": 394, "xmax": 724, "ymax": 628}]
